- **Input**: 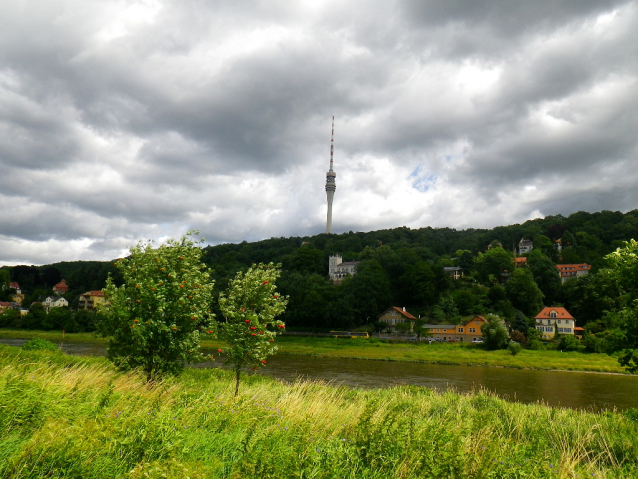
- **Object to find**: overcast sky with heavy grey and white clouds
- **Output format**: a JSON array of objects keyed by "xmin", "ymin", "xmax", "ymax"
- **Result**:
[{"xmin": 0, "ymin": 0, "xmax": 638, "ymax": 265}]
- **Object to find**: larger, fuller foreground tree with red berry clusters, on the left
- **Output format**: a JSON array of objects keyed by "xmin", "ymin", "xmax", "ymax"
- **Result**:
[{"xmin": 98, "ymin": 232, "xmax": 215, "ymax": 381}]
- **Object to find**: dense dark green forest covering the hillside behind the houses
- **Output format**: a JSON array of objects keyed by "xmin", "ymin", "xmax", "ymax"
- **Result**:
[{"xmin": 0, "ymin": 210, "xmax": 638, "ymax": 344}]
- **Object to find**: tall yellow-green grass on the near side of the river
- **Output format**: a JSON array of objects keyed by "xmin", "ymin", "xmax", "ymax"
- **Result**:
[{"xmin": 0, "ymin": 347, "xmax": 638, "ymax": 479}]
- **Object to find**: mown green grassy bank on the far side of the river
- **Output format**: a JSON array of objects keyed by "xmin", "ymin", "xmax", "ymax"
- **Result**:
[{"xmin": 0, "ymin": 330, "xmax": 624, "ymax": 374}]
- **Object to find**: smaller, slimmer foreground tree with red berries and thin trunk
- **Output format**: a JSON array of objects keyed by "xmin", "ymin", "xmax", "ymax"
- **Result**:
[{"xmin": 219, "ymin": 263, "xmax": 288, "ymax": 396}]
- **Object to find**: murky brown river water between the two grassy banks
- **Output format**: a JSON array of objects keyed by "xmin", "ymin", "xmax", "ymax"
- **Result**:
[{"xmin": 0, "ymin": 339, "xmax": 638, "ymax": 411}]
